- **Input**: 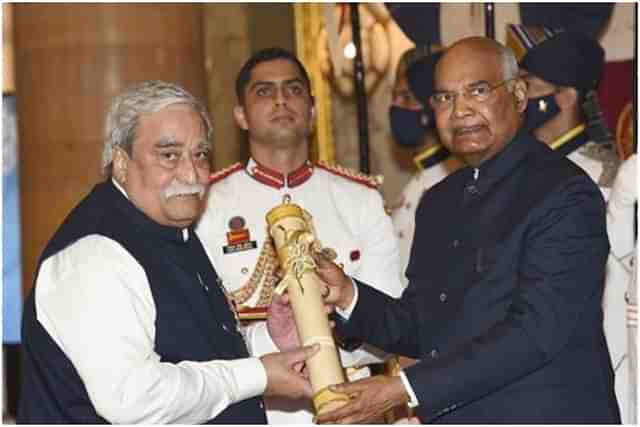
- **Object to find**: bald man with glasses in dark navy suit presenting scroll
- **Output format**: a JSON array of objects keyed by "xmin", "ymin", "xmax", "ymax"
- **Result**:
[{"xmin": 317, "ymin": 37, "xmax": 620, "ymax": 424}]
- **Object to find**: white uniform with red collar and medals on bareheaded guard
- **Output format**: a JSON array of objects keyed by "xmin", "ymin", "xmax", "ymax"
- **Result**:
[{"xmin": 197, "ymin": 159, "xmax": 403, "ymax": 424}]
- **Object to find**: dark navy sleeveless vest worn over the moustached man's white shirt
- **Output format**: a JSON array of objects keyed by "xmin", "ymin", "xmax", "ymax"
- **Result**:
[{"xmin": 18, "ymin": 181, "xmax": 267, "ymax": 424}]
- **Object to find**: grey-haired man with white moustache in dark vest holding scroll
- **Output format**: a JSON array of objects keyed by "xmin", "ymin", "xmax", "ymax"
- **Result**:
[{"xmin": 18, "ymin": 81, "xmax": 314, "ymax": 424}]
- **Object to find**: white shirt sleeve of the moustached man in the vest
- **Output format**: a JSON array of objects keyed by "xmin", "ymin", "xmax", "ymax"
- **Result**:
[{"xmin": 36, "ymin": 235, "xmax": 267, "ymax": 424}]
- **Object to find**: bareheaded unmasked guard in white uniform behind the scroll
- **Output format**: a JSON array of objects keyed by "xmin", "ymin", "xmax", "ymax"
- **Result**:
[{"xmin": 197, "ymin": 48, "xmax": 402, "ymax": 424}]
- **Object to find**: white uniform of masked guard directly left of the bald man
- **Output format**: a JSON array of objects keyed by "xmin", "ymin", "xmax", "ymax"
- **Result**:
[{"xmin": 391, "ymin": 155, "xmax": 463, "ymax": 286}]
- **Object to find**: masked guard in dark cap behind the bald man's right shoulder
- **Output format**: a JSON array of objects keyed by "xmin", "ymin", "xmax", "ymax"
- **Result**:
[{"xmin": 507, "ymin": 25, "xmax": 618, "ymax": 186}]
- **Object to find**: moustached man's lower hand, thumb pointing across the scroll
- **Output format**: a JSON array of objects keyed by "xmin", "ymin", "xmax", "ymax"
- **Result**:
[{"xmin": 260, "ymin": 344, "xmax": 320, "ymax": 399}]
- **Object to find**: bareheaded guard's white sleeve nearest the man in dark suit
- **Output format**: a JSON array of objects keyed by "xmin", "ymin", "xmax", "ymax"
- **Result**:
[{"xmin": 340, "ymin": 191, "xmax": 403, "ymax": 367}]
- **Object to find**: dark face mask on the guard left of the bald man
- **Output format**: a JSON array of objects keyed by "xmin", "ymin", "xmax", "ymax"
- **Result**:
[{"xmin": 389, "ymin": 105, "xmax": 433, "ymax": 147}]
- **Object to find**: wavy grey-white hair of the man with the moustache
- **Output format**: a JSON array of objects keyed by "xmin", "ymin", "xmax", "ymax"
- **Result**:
[{"xmin": 102, "ymin": 80, "xmax": 213, "ymax": 176}]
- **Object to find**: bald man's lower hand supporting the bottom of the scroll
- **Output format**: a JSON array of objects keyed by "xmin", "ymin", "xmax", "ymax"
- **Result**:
[{"xmin": 315, "ymin": 375, "xmax": 407, "ymax": 424}]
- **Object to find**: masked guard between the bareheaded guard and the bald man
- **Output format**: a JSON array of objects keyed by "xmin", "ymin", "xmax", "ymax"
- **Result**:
[{"xmin": 389, "ymin": 46, "xmax": 462, "ymax": 285}]
